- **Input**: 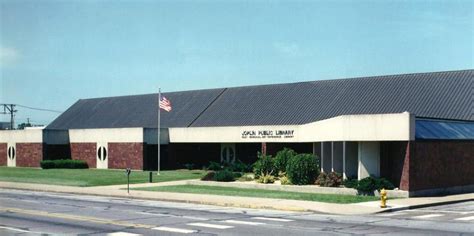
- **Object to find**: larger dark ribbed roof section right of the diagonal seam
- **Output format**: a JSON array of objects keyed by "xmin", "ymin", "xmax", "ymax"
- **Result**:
[{"xmin": 192, "ymin": 70, "xmax": 474, "ymax": 126}]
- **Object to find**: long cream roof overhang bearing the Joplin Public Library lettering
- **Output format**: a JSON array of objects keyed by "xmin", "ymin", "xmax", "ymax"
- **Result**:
[{"xmin": 169, "ymin": 112, "xmax": 415, "ymax": 143}]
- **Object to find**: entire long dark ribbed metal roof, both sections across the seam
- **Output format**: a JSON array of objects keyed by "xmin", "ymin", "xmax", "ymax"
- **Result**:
[{"xmin": 47, "ymin": 70, "xmax": 474, "ymax": 129}]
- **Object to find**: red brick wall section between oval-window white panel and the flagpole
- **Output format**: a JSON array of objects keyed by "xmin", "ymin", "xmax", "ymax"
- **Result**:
[{"xmin": 108, "ymin": 143, "xmax": 143, "ymax": 170}]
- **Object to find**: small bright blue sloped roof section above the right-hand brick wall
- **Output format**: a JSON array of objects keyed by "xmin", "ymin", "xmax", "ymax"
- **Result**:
[{"xmin": 415, "ymin": 119, "xmax": 474, "ymax": 140}]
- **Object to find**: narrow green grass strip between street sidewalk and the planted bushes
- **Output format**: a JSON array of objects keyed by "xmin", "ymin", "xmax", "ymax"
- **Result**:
[{"xmin": 133, "ymin": 185, "xmax": 378, "ymax": 203}]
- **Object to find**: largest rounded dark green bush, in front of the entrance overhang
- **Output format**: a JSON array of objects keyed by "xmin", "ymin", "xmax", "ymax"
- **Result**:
[{"xmin": 286, "ymin": 154, "xmax": 319, "ymax": 185}]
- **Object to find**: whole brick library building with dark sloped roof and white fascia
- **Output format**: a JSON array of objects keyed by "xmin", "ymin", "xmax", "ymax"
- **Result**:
[{"xmin": 0, "ymin": 70, "xmax": 474, "ymax": 195}]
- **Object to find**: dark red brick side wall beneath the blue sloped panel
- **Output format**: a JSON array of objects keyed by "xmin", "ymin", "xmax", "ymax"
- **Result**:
[{"xmin": 409, "ymin": 141, "xmax": 474, "ymax": 191}]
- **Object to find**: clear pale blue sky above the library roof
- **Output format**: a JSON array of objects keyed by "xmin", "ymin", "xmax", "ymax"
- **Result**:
[{"xmin": 0, "ymin": 0, "xmax": 474, "ymax": 124}]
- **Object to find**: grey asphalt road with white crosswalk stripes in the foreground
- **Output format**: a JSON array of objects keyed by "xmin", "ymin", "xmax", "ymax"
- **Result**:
[{"xmin": 0, "ymin": 189, "xmax": 474, "ymax": 236}]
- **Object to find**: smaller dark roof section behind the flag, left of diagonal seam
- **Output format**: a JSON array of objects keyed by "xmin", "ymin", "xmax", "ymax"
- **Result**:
[{"xmin": 46, "ymin": 89, "xmax": 224, "ymax": 130}]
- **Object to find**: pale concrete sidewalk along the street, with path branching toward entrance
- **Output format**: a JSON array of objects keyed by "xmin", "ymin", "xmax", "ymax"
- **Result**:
[{"xmin": 0, "ymin": 180, "xmax": 474, "ymax": 215}]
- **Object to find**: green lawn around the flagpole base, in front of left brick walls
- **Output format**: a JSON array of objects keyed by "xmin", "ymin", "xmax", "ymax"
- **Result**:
[{"xmin": 0, "ymin": 167, "xmax": 206, "ymax": 187}]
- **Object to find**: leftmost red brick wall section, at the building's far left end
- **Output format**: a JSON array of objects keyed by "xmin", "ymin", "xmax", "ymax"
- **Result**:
[{"xmin": 16, "ymin": 143, "xmax": 43, "ymax": 167}]
